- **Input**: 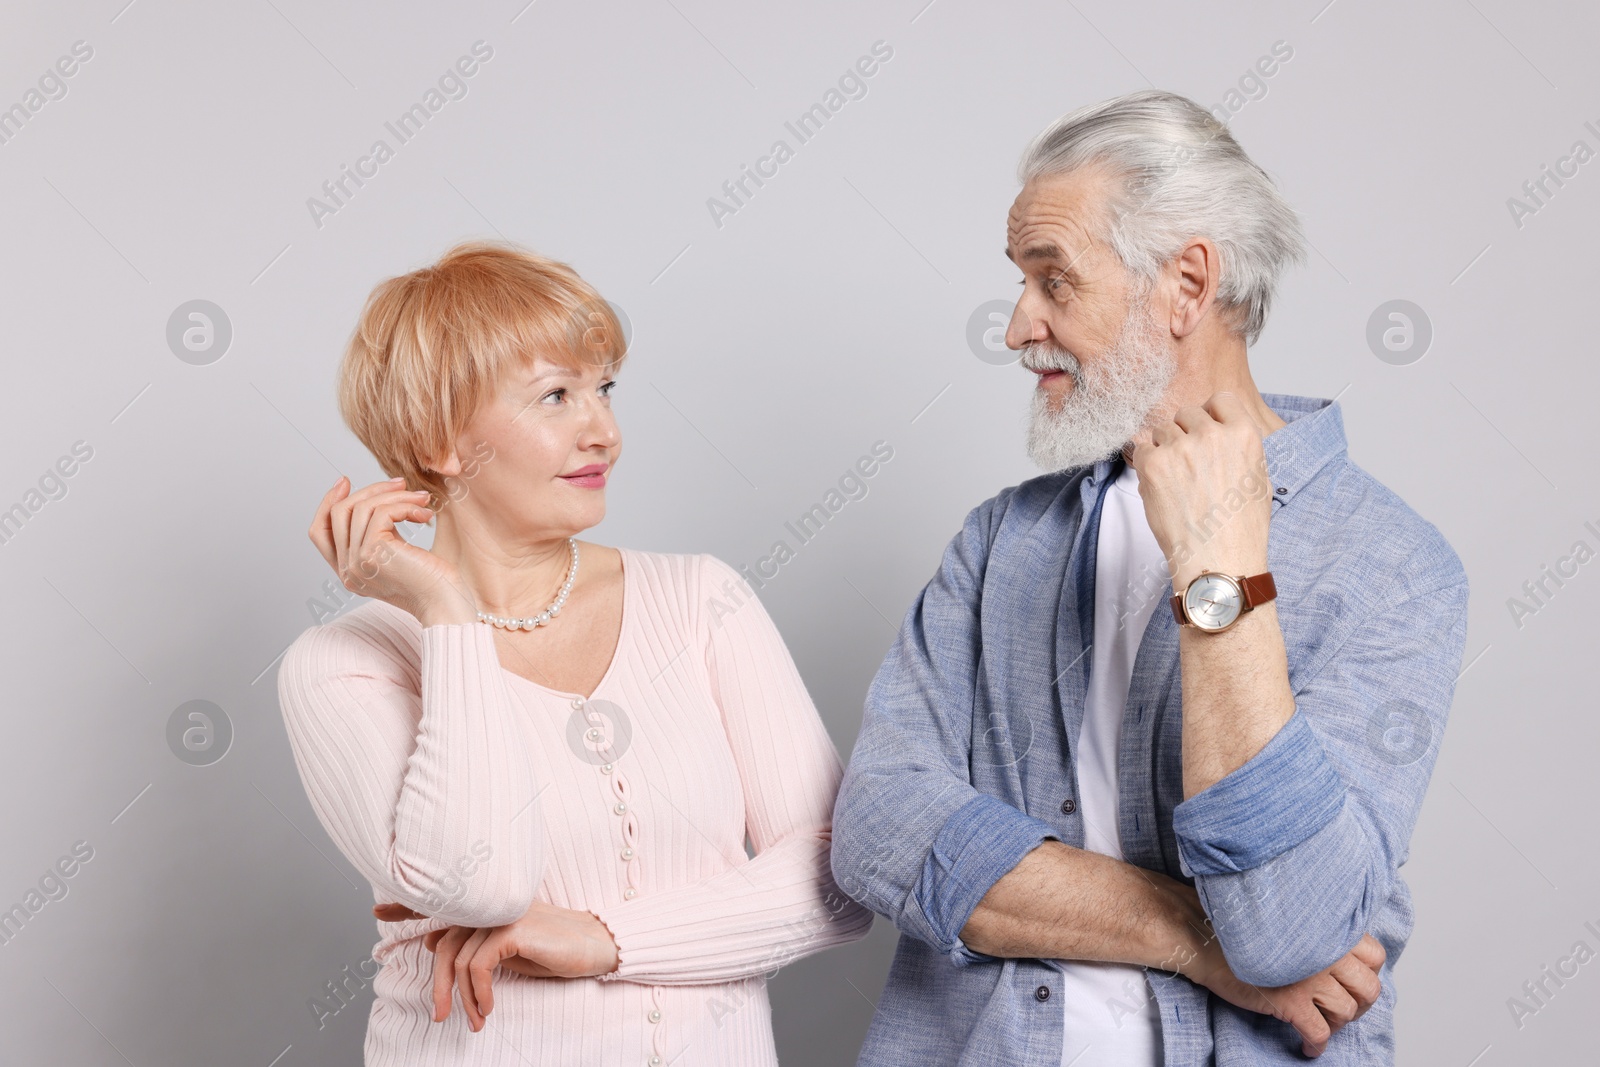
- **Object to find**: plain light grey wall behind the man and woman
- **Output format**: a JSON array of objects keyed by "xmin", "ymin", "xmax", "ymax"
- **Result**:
[{"xmin": 0, "ymin": 0, "xmax": 1600, "ymax": 1067}]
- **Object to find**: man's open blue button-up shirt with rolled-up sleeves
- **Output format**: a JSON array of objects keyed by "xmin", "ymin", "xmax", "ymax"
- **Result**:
[{"xmin": 832, "ymin": 394, "xmax": 1467, "ymax": 1067}]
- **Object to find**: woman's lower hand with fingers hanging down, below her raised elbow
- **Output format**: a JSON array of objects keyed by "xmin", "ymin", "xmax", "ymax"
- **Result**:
[{"xmin": 373, "ymin": 901, "xmax": 618, "ymax": 1033}]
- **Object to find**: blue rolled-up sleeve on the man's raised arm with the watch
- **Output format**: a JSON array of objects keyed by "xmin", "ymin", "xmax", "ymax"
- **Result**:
[{"xmin": 1173, "ymin": 539, "xmax": 1467, "ymax": 985}]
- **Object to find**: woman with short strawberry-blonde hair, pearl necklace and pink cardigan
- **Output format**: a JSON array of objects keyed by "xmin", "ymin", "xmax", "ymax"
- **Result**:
[{"xmin": 278, "ymin": 243, "xmax": 872, "ymax": 1067}]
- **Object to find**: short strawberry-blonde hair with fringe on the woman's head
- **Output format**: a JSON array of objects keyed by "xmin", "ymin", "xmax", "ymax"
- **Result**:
[{"xmin": 339, "ymin": 242, "xmax": 627, "ymax": 502}]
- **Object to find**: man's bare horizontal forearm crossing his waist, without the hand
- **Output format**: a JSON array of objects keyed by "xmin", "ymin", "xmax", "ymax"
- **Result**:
[{"xmin": 962, "ymin": 841, "xmax": 1210, "ymax": 971}]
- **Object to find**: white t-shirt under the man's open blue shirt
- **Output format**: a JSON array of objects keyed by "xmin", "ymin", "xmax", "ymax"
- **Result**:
[{"xmin": 1054, "ymin": 466, "xmax": 1171, "ymax": 1067}]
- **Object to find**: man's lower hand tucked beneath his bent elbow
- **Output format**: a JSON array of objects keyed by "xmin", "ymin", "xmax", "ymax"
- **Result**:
[{"xmin": 1184, "ymin": 934, "xmax": 1387, "ymax": 1057}]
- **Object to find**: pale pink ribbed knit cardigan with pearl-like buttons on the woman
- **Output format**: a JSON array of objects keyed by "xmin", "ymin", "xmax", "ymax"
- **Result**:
[{"xmin": 278, "ymin": 549, "xmax": 872, "ymax": 1067}]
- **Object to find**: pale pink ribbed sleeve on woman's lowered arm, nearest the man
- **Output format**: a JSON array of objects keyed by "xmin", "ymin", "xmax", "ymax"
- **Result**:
[{"xmin": 594, "ymin": 553, "xmax": 874, "ymax": 984}]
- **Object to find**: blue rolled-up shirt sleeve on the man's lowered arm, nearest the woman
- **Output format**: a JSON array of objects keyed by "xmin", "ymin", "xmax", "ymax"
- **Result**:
[{"xmin": 832, "ymin": 494, "xmax": 1056, "ymax": 966}]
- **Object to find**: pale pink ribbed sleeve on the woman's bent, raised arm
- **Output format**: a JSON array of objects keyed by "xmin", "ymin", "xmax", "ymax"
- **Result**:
[{"xmin": 278, "ymin": 614, "xmax": 544, "ymax": 926}]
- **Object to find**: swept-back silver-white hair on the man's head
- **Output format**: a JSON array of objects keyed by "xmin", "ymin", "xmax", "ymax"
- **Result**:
[{"xmin": 1018, "ymin": 90, "xmax": 1306, "ymax": 344}]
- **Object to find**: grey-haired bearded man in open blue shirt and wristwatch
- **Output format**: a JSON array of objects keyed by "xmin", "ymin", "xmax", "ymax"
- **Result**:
[{"xmin": 834, "ymin": 91, "xmax": 1467, "ymax": 1067}]
